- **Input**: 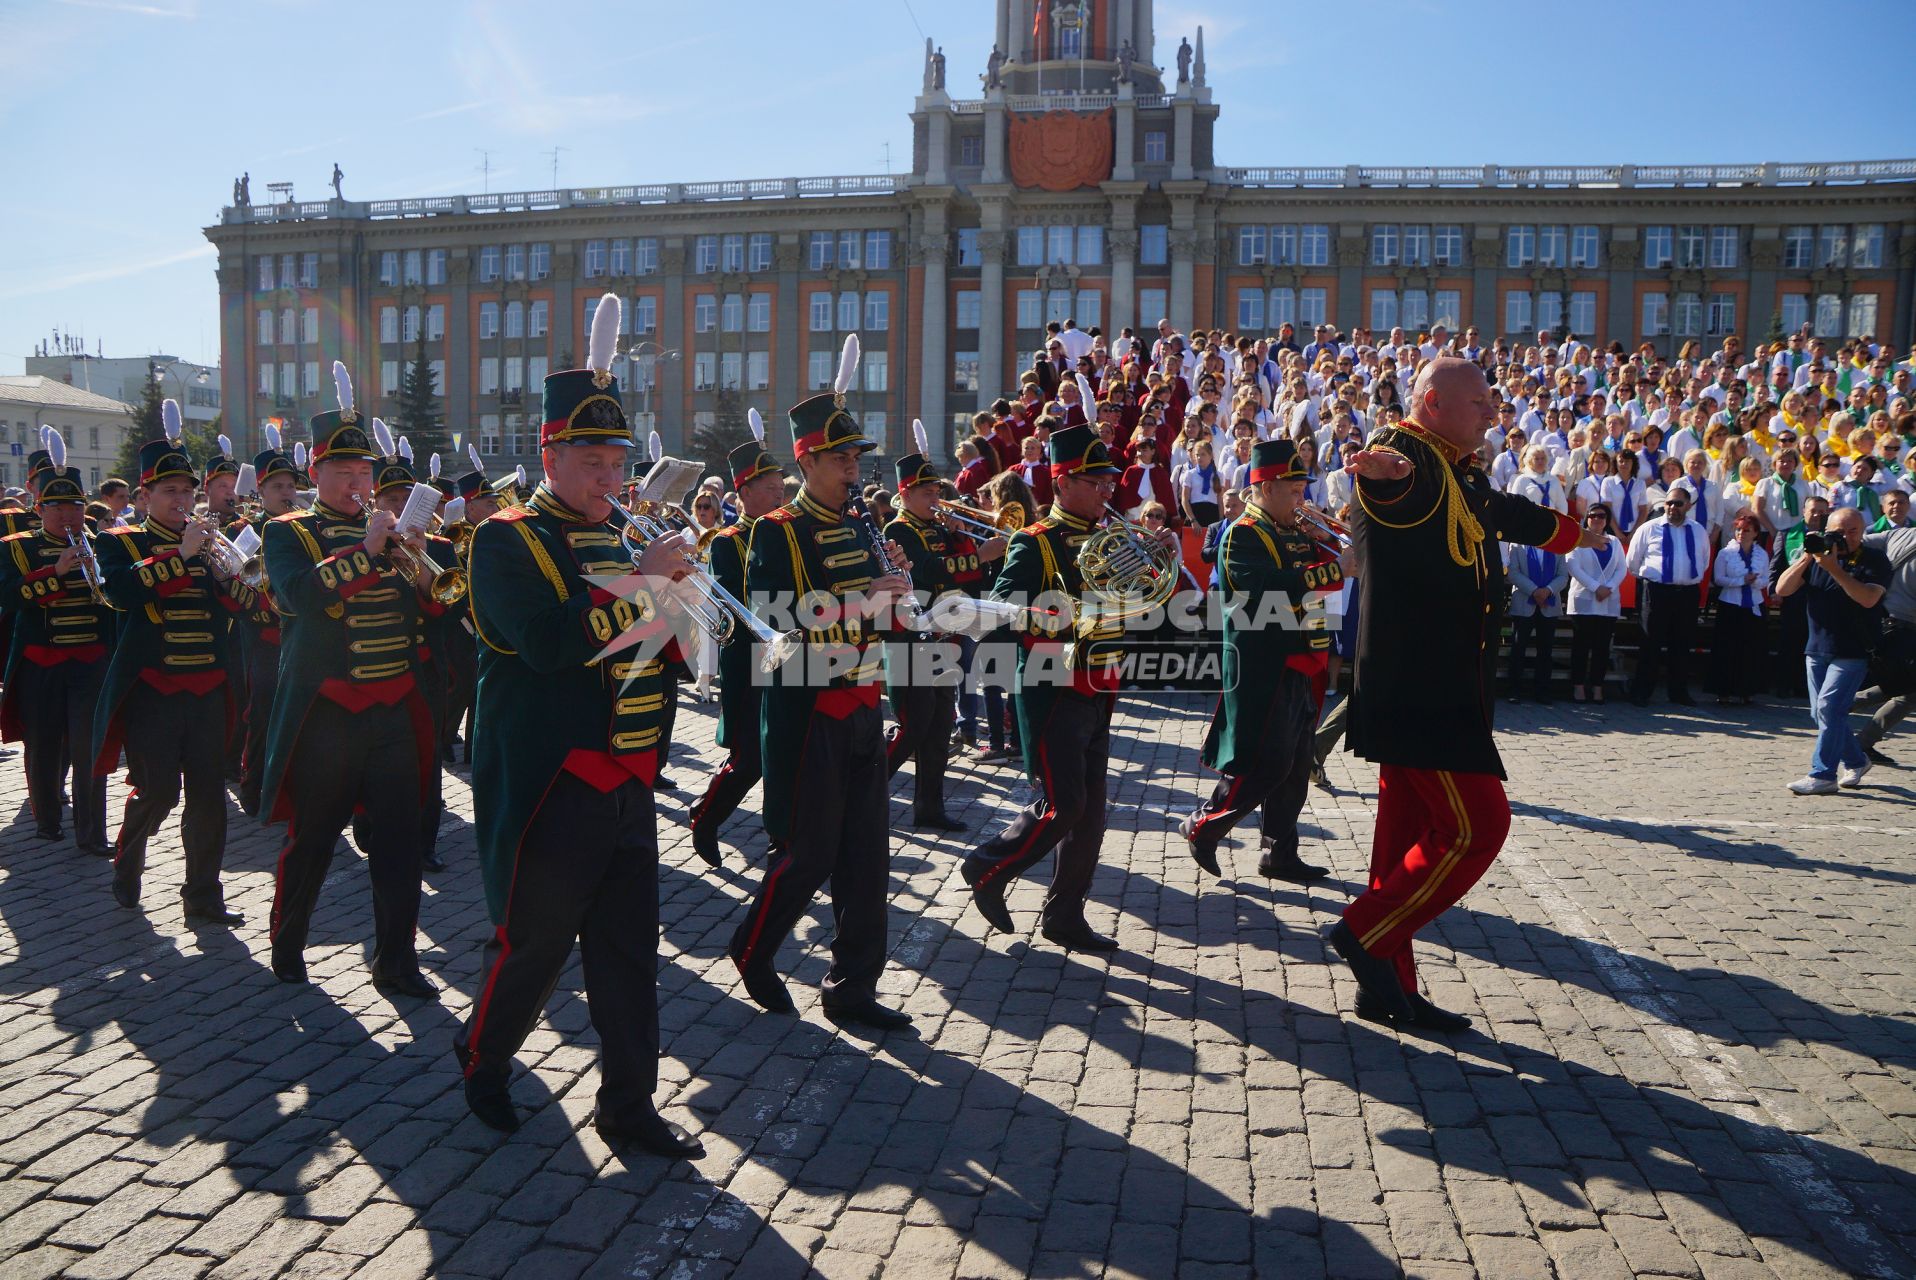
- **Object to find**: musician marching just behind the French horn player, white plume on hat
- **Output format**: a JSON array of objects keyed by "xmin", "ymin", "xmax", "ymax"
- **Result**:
[{"xmin": 885, "ymin": 422, "xmax": 1004, "ymax": 832}]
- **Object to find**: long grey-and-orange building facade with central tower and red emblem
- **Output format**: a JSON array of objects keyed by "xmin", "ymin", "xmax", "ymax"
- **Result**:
[{"xmin": 207, "ymin": 0, "xmax": 1916, "ymax": 468}]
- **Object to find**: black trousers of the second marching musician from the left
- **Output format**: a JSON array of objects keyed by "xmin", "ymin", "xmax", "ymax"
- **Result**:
[{"xmin": 113, "ymin": 682, "xmax": 226, "ymax": 910}]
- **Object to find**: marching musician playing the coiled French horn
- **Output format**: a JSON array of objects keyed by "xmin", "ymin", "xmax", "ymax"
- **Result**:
[{"xmin": 962, "ymin": 423, "xmax": 1123, "ymax": 950}]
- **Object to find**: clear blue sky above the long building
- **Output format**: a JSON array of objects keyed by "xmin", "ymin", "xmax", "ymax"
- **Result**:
[{"xmin": 0, "ymin": 0, "xmax": 1916, "ymax": 374}]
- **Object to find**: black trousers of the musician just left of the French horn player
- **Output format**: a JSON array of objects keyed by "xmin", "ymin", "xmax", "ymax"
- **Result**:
[{"xmin": 730, "ymin": 707, "xmax": 891, "ymax": 1004}]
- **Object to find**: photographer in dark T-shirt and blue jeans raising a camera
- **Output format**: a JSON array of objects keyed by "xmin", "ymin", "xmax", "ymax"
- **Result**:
[{"xmin": 1776, "ymin": 508, "xmax": 1891, "ymax": 795}]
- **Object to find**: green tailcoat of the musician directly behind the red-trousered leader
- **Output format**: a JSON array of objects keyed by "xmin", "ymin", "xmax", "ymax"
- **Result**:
[{"xmin": 1203, "ymin": 504, "xmax": 1343, "ymax": 776}]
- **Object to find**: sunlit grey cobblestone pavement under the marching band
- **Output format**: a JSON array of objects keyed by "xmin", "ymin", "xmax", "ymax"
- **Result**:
[{"xmin": 0, "ymin": 699, "xmax": 1916, "ymax": 1280}]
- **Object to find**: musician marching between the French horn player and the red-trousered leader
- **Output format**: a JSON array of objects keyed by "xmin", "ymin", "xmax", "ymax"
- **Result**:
[{"xmin": 1178, "ymin": 439, "xmax": 1343, "ymax": 880}]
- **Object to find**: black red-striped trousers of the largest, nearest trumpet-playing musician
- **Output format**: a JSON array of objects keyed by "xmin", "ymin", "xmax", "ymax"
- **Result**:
[{"xmin": 454, "ymin": 774, "xmax": 659, "ymax": 1125}]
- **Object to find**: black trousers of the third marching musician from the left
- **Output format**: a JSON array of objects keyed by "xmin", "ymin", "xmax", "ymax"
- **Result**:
[{"xmin": 272, "ymin": 697, "xmax": 420, "ymax": 975}]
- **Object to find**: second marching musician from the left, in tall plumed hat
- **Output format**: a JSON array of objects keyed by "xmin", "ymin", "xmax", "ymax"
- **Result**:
[{"xmin": 94, "ymin": 400, "xmax": 255, "ymax": 924}]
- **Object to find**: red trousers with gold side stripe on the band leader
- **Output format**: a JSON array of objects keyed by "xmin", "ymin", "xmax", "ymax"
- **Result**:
[{"xmin": 1343, "ymin": 765, "xmax": 1510, "ymax": 991}]
